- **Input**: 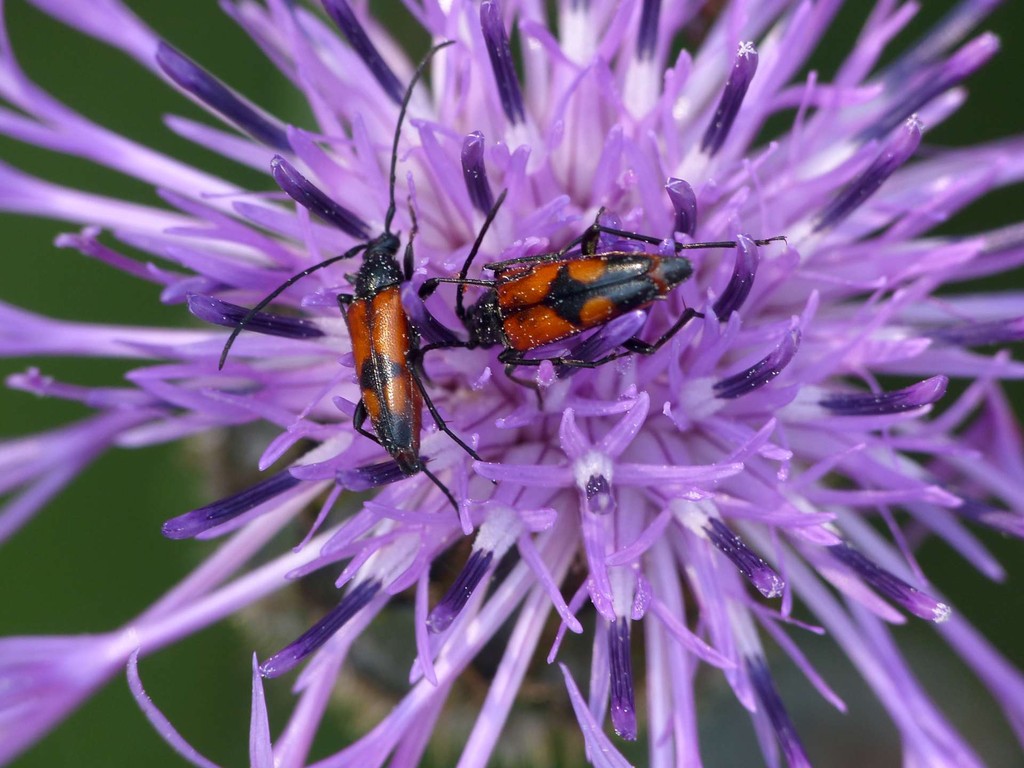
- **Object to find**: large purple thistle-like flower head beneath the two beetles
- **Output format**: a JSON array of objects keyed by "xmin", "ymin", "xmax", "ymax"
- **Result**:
[{"xmin": 0, "ymin": 0, "xmax": 1024, "ymax": 768}]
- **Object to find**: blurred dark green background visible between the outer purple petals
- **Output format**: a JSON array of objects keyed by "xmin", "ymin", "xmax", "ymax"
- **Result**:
[{"xmin": 0, "ymin": 0, "xmax": 1024, "ymax": 768}]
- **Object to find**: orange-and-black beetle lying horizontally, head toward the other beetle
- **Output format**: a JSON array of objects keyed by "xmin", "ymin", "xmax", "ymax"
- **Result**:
[{"xmin": 419, "ymin": 190, "xmax": 785, "ymax": 386}]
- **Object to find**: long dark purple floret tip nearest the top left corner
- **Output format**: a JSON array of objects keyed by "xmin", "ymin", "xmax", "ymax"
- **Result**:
[{"xmin": 157, "ymin": 40, "xmax": 292, "ymax": 152}]
